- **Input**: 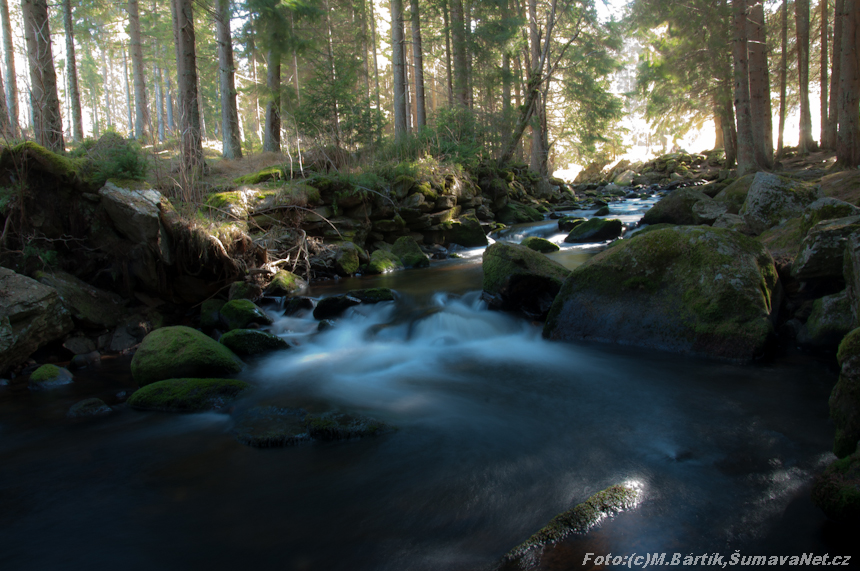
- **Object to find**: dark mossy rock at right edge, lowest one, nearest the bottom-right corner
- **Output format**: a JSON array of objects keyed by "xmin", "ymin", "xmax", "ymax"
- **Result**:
[{"xmin": 812, "ymin": 452, "xmax": 860, "ymax": 523}]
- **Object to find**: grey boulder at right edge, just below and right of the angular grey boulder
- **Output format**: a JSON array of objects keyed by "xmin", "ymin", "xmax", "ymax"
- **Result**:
[{"xmin": 791, "ymin": 216, "xmax": 860, "ymax": 280}]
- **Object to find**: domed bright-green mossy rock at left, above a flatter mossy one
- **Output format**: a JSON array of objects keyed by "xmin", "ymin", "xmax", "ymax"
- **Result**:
[{"xmin": 131, "ymin": 325, "xmax": 244, "ymax": 387}]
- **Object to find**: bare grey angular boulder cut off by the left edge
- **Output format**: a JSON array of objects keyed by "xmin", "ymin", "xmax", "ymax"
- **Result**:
[{"xmin": 0, "ymin": 267, "xmax": 74, "ymax": 373}]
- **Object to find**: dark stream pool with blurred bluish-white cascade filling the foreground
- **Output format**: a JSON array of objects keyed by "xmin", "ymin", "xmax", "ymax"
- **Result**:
[{"xmin": 0, "ymin": 199, "xmax": 857, "ymax": 571}]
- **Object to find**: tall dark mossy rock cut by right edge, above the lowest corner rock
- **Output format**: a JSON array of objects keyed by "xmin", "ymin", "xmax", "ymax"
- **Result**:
[{"xmin": 830, "ymin": 329, "xmax": 860, "ymax": 458}]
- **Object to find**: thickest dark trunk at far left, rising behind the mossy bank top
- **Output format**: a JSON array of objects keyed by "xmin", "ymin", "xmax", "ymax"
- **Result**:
[{"xmin": 21, "ymin": 0, "xmax": 65, "ymax": 153}]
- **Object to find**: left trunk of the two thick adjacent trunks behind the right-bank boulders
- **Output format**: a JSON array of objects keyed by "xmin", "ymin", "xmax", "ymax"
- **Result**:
[{"xmin": 732, "ymin": 0, "xmax": 759, "ymax": 176}]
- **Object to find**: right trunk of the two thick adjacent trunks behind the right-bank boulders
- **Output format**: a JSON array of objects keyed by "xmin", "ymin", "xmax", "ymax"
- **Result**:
[{"xmin": 747, "ymin": 0, "xmax": 773, "ymax": 169}]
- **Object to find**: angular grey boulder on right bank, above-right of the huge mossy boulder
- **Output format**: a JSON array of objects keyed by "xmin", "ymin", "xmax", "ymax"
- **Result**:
[{"xmin": 739, "ymin": 172, "xmax": 822, "ymax": 234}]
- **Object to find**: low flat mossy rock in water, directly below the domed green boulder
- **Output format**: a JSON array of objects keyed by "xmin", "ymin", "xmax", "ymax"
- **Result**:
[{"xmin": 128, "ymin": 379, "xmax": 251, "ymax": 412}]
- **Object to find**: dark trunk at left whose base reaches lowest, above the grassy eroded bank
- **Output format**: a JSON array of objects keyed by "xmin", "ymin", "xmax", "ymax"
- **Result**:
[{"xmin": 172, "ymin": 0, "xmax": 204, "ymax": 172}]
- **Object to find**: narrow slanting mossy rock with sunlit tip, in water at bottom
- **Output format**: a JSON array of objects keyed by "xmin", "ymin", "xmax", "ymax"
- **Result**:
[{"xmin": 504, "ymin": 484, "xmax": 642, "ymax": 561}]
